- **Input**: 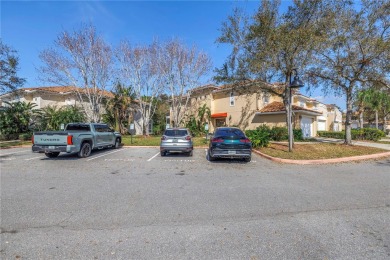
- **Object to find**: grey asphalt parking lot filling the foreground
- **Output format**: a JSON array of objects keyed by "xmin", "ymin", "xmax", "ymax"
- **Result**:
[{"xmin": 0, "ymin": 148, "xmax": 390, "ymax": 259}]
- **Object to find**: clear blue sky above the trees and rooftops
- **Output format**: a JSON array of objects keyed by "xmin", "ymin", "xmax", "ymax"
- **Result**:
[{"xmin": 0, "ymin": 0, "xmax": 345, "ymax": 110}]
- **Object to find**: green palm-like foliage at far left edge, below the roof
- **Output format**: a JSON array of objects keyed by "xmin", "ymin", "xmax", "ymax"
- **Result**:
[{"xmin": 0, "ymin": 101, "xmax": 40, "ymax": 138}]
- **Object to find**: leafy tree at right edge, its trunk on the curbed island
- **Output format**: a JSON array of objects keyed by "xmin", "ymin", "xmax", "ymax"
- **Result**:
[{"xmin": 310, "ymin": 0, "xmax": 390, "ymax": 144}]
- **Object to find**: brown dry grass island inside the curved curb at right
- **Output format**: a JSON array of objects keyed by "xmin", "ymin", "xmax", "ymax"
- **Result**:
[{"xmin": 257, "ymin": 143, "xmax": 388, "ymax": 160}]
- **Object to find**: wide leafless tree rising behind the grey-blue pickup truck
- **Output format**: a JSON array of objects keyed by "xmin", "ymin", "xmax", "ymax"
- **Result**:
[{"xmin": 38, "ymin": 25, "xmax": 113, "ymax": 122}]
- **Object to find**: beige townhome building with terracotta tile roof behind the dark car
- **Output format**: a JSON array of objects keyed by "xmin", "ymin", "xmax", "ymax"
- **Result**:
[{"xmin": 180, "ymin": 85, "xmax": 342, "ymax": 138}]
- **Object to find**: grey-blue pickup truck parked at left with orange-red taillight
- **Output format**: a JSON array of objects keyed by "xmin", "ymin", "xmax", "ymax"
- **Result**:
[{"xmin": 32, "ymin": 123, "xmax": 122, "ymax": 158}]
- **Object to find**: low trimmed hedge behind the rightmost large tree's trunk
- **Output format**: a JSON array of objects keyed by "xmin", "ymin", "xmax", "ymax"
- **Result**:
[{"xmin": 317, "ymin": 128, "xmax": 386, "ymax": 141}]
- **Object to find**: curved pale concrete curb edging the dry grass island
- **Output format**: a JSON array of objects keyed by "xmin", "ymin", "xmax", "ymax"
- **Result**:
[{"xmin": 252, "ymin": 150, "xmax": 390, "ymax": 165}]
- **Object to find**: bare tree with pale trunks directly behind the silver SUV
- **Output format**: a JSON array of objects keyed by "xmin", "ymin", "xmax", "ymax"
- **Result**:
[{"xmin": 157, "ymin": 39, "xmax": 211, "ymax": 126}]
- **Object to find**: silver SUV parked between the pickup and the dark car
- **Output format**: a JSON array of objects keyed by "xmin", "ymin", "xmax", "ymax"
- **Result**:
[{"xmin": 160, "ymin": 128, "xmax": 194, "ymax": 156}]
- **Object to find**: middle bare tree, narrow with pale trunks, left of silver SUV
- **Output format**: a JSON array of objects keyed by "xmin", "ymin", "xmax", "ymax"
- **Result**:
[{"xmin": 116, "ymin": 41, "xmax": 163, "ymax": 135}]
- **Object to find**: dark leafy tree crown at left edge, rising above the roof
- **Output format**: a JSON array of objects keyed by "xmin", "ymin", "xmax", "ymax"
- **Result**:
[{"xmin": 0, "ymin": 38, "xmax": 25, "ymax": 94}]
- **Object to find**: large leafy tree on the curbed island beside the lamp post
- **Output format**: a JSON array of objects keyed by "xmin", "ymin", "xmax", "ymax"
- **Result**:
[{"xmin": 215, "ymin": 0, "xmax": 325, "ymax": 151}]
